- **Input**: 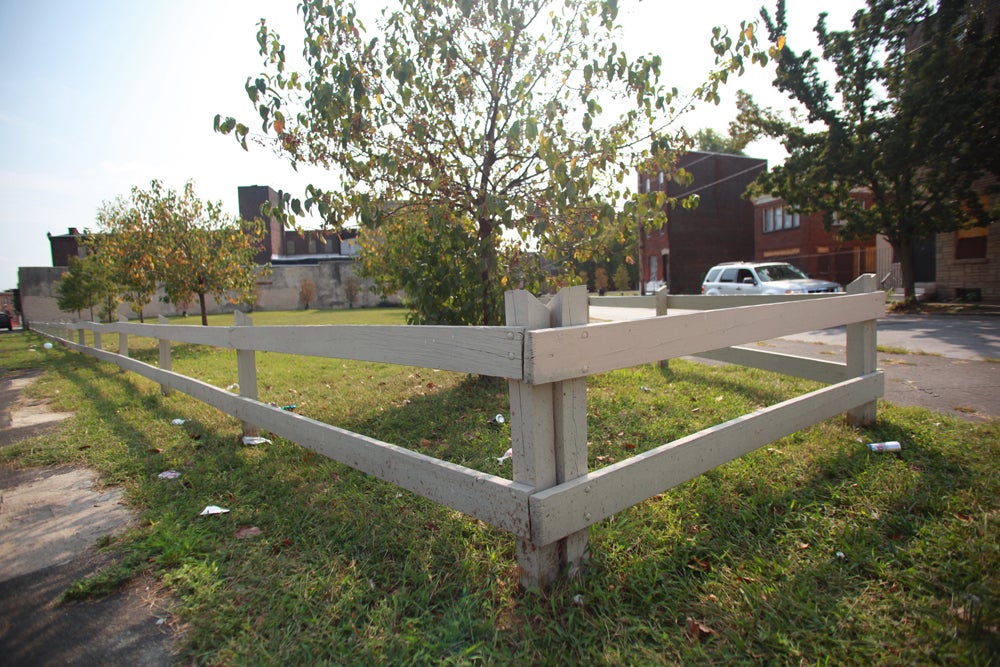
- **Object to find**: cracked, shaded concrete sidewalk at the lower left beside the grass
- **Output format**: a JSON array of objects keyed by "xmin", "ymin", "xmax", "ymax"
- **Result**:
[{"xmin": 0, "ymin": 377, "xmax": 173, "ymax": 667}]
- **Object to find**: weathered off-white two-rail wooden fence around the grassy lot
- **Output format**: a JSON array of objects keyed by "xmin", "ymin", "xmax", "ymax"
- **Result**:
[{"xmin": 34, "ymin": 275, "xmax": 885, "ymax": 587}]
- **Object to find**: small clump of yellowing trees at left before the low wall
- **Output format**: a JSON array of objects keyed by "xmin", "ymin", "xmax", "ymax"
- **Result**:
[{"xmin": 57, "ymin": 180, "xmax": 268, "ymax": 325}]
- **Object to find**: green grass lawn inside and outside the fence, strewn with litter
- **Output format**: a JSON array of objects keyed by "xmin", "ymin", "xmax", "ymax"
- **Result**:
[{"xmin": 0, "ymin": 316, "xmax": 1000, "ymax": 665}]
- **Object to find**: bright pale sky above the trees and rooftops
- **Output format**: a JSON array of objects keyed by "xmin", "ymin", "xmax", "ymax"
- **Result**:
[{"xmin": 0, "ymin": 0, "xmax": 863, "ymax": 290}]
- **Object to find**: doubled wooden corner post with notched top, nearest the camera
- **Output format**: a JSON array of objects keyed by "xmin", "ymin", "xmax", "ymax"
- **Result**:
[{"xmin": 506, "ymin": 286, "xmax": 590, "ymax": 588}]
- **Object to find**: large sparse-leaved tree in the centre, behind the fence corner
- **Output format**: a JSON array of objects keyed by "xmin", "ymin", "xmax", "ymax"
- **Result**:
[{"xmin": 215, "ymin": 0, "xmax": 758, "ymax": 325}]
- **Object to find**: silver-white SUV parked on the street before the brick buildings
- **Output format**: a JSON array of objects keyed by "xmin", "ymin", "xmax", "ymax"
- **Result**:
[{"xmin": 701, "ymin": 262, "xmax": 844, "ymax": 295}]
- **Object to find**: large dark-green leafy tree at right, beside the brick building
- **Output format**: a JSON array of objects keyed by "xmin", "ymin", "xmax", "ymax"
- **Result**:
[{"xmin": 736, "ymin": 0, "xmax": 1000, "ymax": 300}]
